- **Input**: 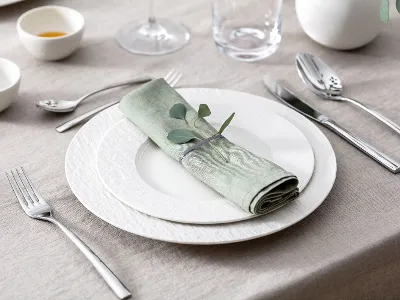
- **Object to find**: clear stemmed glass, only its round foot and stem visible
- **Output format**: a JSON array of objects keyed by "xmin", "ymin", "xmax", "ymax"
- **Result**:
[{"xmin": 117, "ymin": 0, "xmax": 190, "ymax": 55}]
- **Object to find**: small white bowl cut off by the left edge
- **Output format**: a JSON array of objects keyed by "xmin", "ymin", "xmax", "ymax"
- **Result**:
[{"xmin": 0, "ymin": 58, "xmax": 21, "ymax": 112}]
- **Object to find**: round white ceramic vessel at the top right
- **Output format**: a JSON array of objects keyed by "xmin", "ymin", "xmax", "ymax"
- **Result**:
[{"xmin": 296, "ymin": 0, "xmax": 384, "ymax": 50}]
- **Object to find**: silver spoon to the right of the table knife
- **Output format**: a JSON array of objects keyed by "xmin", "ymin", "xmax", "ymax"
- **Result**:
[{"xmin": 296, "ymin": 53, "xmax": 400, "ymax": 134}]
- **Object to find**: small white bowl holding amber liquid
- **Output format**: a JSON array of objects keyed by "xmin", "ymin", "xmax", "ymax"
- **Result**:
[{"xmin": 17, "ymin": 5, "xmax": 85, "ymax": 60}]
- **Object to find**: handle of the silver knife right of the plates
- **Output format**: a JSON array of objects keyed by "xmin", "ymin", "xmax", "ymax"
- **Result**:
[{"xmin": 321, "ymin": 119, "xmax": 400, "ymax": 174}]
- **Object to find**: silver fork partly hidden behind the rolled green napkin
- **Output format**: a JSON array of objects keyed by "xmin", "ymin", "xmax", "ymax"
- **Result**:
[{"xmin": 56, "ymin": 69, "xmax": 182, "ymax": 133}]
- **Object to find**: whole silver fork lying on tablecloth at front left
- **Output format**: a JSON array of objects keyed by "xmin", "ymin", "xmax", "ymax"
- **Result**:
[{"xmin": 6, "ymin": 167, "xmax": 132, "ymax": 299}]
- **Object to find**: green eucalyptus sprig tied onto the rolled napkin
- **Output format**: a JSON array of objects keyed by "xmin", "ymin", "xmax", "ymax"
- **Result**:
[{"xmin": 167, "ymin": 103, "xmax": 235, "ymax": 162}]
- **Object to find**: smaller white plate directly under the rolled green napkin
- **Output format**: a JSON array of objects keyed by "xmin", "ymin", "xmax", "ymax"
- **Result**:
[{"xmin": 97, "ymin": 89, "xmax": 314, "ymax": 224}]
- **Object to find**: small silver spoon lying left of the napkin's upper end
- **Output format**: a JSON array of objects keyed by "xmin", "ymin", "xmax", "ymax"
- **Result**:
[{"xmin": 36, "ymin": 76, "xmax": 152, "ymax": 113}]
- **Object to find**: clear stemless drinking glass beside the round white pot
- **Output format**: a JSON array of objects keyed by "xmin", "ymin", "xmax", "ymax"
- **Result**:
[{"xmin": 212, "ymin": 0, "xmax": 283, "ymax": 61}]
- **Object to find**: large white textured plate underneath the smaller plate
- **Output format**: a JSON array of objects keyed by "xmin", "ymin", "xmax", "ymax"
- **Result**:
[{"xmin": 65, "ymin": 89, "xmax": 336, "ymax": 245}]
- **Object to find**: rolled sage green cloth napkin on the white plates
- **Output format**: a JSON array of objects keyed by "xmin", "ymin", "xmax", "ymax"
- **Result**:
[{"xmin": 119, "ymin": 79, "xmax": 299, "ymax": 215}]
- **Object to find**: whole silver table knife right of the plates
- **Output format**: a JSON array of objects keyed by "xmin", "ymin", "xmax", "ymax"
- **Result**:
[{"xmin": 264, "ymin": 76, "xmax": 400, "ymax": 174}]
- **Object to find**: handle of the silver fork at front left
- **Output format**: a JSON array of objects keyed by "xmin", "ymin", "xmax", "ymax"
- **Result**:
[{"xmin": 41, "ymin": 217, "xmax": 132, "ymax": 300}]
